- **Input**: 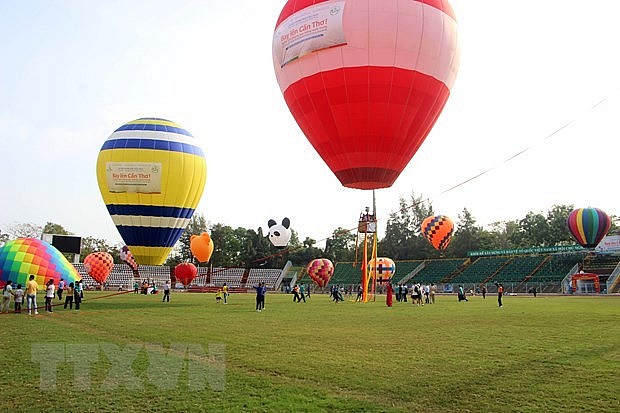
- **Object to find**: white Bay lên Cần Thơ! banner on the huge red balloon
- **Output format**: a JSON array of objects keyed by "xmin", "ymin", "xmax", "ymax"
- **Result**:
[{"xmin": 273, "ymin": 1, "xmax": 347, "ymax": 67}]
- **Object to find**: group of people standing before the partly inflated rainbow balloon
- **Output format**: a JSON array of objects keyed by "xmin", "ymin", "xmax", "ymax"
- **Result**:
[{"xmin": 0, "ymin": 274, "xmax": 84, "ymax": 315}]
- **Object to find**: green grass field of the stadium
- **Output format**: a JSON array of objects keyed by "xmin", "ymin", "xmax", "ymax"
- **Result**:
[{"xmin": 0, "ymin": 292, "xmax": 620, "ymax": 412}]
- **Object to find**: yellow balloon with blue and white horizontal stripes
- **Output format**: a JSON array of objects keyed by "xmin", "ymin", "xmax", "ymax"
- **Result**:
[{"xmin": 97, "ymin": 118, "xmax": 207, "ymax": 265}]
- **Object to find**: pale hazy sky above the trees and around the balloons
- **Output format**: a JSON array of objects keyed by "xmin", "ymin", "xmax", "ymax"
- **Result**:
[{"xmin": 0, "ymin": 0, "xmax": 620, "ymax": 248}]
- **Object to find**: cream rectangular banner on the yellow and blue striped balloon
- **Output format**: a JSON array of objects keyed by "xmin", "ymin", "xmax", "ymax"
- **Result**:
[{"xmin": 105, "ymin": 162, "xmax": 161, "ymax": 194}]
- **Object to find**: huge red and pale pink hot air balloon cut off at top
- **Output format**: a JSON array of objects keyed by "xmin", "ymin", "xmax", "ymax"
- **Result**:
[{"xmin": 273, "ymin": 0, "xmax": 459, "ymax": 189}]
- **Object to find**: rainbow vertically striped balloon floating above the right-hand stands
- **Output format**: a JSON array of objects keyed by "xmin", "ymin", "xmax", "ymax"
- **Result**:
[{"xmin": 567, "ymin": 208, "xmax": 611, "ymax": 248}]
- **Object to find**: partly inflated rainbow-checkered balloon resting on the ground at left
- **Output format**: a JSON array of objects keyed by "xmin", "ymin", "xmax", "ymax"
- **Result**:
[{"xmin": 0, "ymin": 238, "xmax": 81, "ymax": 289}]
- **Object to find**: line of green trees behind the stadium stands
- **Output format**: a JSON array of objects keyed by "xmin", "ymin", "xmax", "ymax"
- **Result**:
[{"xmin": 0, "ymin": 193, "xmax": 618, "ymax": 268}]
